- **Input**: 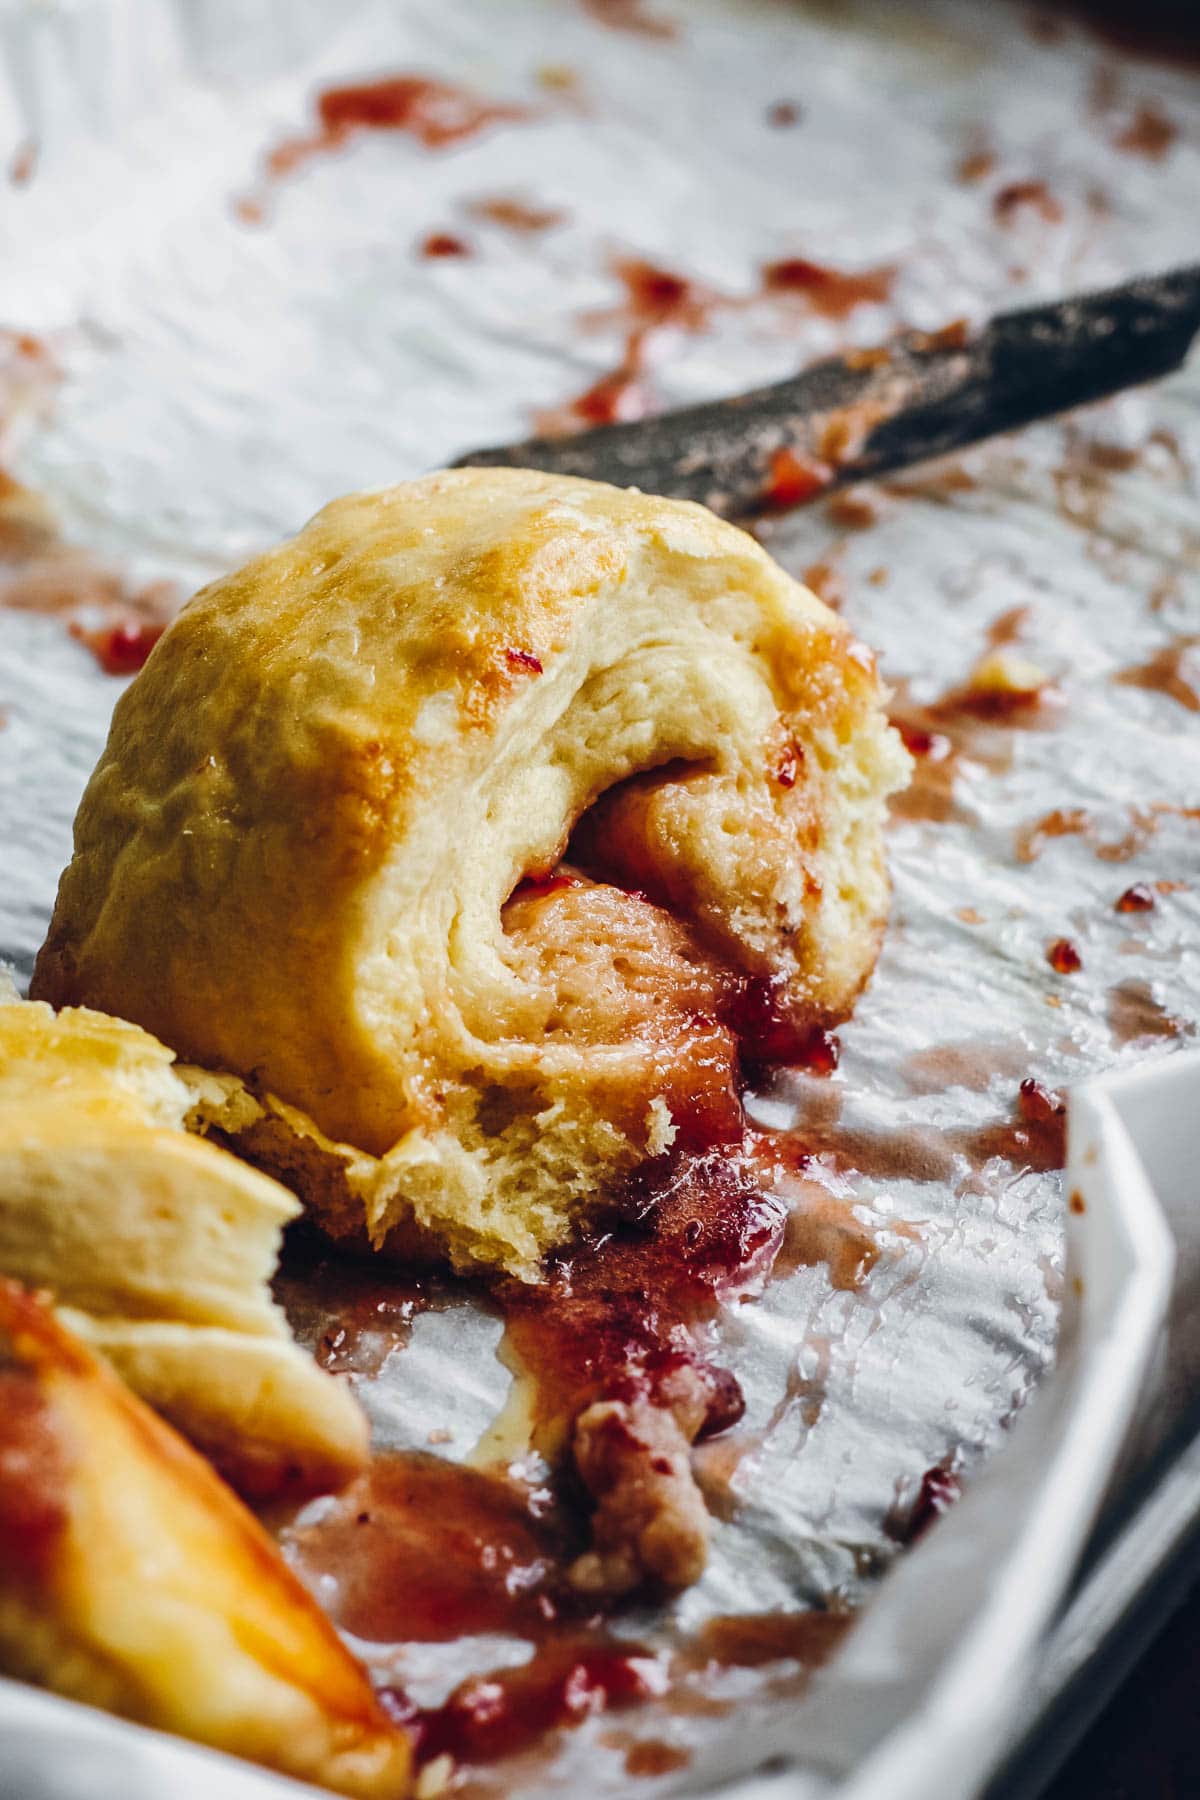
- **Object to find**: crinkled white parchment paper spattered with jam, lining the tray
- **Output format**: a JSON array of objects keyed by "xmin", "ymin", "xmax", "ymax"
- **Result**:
[{"xmin": 0, "ymin": 0, "xmax": 1200, "ymax": 1795}]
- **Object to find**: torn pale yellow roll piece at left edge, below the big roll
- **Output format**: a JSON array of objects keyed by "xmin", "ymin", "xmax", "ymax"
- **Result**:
[{"xmin": 0, "ymin": 995, "xmax": 367, "ymax": 1492}]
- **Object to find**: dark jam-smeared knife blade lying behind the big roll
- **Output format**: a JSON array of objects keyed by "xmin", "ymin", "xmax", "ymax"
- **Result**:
[{"xmin": 455, "ymin": 265, "xmax": 1200, "ymax": 518}]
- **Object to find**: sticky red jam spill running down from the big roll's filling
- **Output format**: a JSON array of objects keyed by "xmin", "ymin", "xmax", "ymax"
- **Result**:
[{"xmin": 264, "ymin": 849, "xmax": 1065, "ymax": 1778}]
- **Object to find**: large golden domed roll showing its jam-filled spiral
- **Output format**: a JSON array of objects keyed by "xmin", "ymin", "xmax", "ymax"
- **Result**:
[{"xmin": 36, "ymin": 470, "xmax": 909, "ymax": 1274}]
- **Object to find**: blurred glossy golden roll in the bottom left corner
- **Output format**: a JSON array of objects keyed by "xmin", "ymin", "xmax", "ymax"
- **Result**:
[{"xmin": 0, "ymin": 1278, "xmax": 410, "ymax": 1800}]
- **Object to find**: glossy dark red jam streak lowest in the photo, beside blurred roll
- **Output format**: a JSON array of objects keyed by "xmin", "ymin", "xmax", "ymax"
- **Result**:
[{"xmin": 380, "ymin": 1636, "xmax": 667, "ymax": 1764}]
